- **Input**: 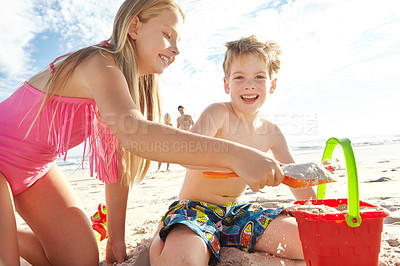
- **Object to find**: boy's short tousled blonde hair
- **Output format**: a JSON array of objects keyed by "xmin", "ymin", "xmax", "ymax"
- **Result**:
[{"xmin": 222, "ymin": 35, "xmax": 282, "ymax": 80}]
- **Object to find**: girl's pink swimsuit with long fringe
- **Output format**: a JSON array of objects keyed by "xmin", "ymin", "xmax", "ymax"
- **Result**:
[{"xmin": 0, "ymin": 82, "xmax": 118, "ymax": 195}]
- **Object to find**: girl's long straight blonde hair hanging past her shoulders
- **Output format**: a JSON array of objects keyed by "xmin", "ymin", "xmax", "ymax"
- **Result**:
[{"xmin": 33, "ymin": 0, "xmax": 185, "ymax": 185}]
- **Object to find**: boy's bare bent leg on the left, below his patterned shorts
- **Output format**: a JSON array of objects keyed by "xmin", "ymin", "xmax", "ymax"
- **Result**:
[{"xmin": 150, "ymin": 224, "xmax": 211, "ymax": 266}]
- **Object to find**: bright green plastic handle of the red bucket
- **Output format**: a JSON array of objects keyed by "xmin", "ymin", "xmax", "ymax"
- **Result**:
[{"xmin": 317, "ymin": 138, "xmax": 361, "ymax": 227}]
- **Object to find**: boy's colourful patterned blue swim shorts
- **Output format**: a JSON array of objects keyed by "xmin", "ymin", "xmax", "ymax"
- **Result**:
[{"xmin": 160, "ymin": 200, "xmax": 283, "ymax": 263}]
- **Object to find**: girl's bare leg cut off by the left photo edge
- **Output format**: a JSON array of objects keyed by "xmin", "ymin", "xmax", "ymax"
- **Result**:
[{"xmin": 0, "ymin": 173, "xmax": 19, "ymax": 265}]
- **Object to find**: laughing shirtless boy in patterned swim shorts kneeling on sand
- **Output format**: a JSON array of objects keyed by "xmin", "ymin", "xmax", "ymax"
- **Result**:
[{"xmin": 150, "ymin": 36, "xmax": 316, "ymax": 265}]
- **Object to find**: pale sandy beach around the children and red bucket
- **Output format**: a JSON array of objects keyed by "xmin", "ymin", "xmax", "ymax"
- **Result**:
[{"xmin": 17, "ymin": 142, "xmax": 400, "ymax": 265}]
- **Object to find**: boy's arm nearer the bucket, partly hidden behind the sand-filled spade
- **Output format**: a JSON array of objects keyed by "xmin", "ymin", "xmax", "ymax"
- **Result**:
[{"xmin": 268, "ymin": 123, "xmax": 317, "ymax": 200}]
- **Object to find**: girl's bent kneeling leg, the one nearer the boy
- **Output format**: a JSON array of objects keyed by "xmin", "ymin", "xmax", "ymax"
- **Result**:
[{"xmin": 15, "ymin": 165, "xmax": 99, "ymax": 265}]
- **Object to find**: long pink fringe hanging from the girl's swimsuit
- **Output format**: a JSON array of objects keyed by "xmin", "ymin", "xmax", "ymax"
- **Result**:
[{"xmin": 36, "ymin": 96, "xmax": 119, "ymax": 183}]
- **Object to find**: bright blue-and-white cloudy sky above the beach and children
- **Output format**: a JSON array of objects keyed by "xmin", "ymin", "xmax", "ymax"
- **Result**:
[{"xmin": 0, "ymin": 0, "xmax": 400, "ymax": 145}]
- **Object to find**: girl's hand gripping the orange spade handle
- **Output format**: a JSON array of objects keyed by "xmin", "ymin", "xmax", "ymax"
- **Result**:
[{"xmin": 232, "ymin": 150, "xmax": 284, "ymax": 192}]
